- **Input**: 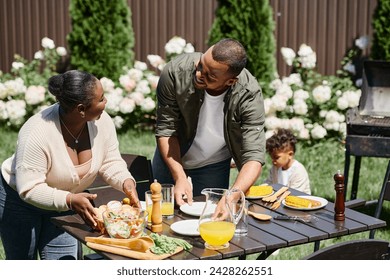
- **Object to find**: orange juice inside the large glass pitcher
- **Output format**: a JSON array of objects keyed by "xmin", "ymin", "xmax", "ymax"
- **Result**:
[{"xmin": 199, "ymin": 221, "xmax": 236, "ymax": 246}]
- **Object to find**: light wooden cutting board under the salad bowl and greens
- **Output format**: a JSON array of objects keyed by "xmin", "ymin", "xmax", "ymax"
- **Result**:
[{"xmin": 87, "ymin": 242, "xmax": 183, "ymax": 260}]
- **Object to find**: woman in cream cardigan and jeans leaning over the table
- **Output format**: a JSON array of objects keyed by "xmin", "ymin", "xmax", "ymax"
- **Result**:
[{"xmin": 0, "ymin": 70, "xmax": 139, "ymax": 259}]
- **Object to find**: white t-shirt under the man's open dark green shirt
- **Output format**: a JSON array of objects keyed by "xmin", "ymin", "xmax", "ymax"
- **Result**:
[{"xmin": 182, "ymin": 92, "xmax": 230, "ymax": 169}]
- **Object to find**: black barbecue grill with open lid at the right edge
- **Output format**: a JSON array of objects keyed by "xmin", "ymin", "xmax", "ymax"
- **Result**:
[{"xmin": 344, "ymin": 60, "xmax": 390, "ymax": 199}]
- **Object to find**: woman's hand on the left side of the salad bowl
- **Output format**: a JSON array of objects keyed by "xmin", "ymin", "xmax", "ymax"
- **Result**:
[{"xmin": 66, "ymin": 193, "xmax": 98, "ymax": 228}]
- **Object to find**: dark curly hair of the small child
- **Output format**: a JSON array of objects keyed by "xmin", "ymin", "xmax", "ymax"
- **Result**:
[{"xmin": 266, "ymin": 128, "xmax": 297, "ymax": 154}]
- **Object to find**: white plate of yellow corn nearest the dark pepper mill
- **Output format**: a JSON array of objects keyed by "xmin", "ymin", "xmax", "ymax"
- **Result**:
[{"xmin": 282, "ymin": 195, "xmax": 328, "ymax": 210}]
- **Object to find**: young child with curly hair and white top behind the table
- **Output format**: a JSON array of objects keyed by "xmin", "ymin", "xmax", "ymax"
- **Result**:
[{"xmin": 265, "ymin": 129, "xmax": 311, "ymax": 195}]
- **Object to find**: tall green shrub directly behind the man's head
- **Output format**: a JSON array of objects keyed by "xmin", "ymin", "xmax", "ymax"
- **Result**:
[{"xmin": 208, "ymin": 0, "xmax": 276, "ymax": 95}]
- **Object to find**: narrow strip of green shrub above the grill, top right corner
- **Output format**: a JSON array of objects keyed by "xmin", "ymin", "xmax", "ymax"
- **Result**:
[{"xmin": 371, "ymin": 0, "xmax": 390, "ymax": 60}]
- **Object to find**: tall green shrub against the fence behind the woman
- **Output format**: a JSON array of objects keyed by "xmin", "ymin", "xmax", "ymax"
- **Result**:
[{"xmin": 67, "ymin": 0, "xmax": 134, "ymax": 80}]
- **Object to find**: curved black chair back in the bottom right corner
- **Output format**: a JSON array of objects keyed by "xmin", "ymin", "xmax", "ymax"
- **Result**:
[{"xmin": 303, "ymin": 239, "xmax": 390, "ymax": 260}]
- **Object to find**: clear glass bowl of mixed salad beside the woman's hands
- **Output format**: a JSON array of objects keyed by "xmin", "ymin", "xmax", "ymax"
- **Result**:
[{"xmin": 102, "ymin": 205, "xmax": 148, "ymax": 239}]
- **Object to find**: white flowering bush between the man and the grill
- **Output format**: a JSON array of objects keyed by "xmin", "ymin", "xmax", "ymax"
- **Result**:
[{"xmin": 264, "ymin": 41, "xmax": 363, "ymax": 143}]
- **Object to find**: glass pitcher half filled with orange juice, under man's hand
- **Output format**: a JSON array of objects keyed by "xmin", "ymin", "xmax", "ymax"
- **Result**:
[{"xmin": 199, "ymin": 188, "xmax": 245, "ymax": 250}]
